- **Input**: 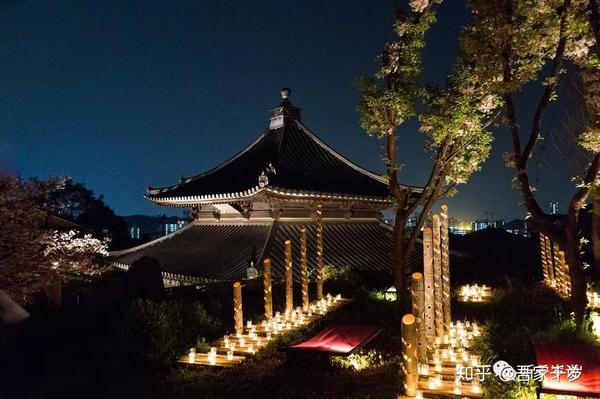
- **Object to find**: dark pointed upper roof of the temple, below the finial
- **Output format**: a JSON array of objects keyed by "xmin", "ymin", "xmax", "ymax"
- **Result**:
[{"xmin": 146, "ymin": 100, "xmax": 420, "ymax": 205}]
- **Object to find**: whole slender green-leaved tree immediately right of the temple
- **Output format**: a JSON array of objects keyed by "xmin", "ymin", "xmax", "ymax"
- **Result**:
[{"xmin": 358, "ymin": 0, "xmax": 499, "ymax": 290}]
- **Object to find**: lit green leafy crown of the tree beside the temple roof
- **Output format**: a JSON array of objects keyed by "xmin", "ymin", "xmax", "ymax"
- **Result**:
[{"xmin": 358, "ymin": 0, "xmax": 501, "ymax": 202}]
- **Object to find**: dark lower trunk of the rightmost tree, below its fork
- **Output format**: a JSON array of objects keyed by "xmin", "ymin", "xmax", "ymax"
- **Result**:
[{"xmin": 563, "ymin": 212, "xmax": 587, "ymax": 328}]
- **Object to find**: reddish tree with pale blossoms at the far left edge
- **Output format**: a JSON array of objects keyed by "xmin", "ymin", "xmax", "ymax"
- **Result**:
[{"xmin": 0, "ymin": 175, "xmax": 107, "ymax": 303}]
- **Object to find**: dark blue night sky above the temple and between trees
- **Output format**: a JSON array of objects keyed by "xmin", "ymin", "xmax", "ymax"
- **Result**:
[{"xmin": 0, "ymin": 0, "xmax": 573, "ymax": 219}]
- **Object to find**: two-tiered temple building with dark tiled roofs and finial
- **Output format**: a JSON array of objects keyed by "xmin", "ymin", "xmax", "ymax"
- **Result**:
[{"xmin": 111, "ymin": 88, "xmax": 421, "ymax": 285}]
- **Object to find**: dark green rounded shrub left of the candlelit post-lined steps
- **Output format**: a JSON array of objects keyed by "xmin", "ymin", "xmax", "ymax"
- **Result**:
[{"xmin": 116, "ymin": 299, "xmax": 220, "ymax": 368}]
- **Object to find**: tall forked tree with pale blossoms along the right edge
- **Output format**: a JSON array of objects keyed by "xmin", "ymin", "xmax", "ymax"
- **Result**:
[{"xmin": 463, "ymin": 0, "xmax": 600, "ymax": 325}]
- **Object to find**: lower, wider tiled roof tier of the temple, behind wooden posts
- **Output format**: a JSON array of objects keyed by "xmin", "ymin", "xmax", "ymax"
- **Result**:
[{"xmin": 111, "ymin": 220, "xmax": 422, "ymax": 281}]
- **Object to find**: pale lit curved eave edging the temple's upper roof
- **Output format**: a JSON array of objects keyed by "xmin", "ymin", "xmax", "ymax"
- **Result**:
[{"xmin": 146, "ymin": 186, "xmax": 414, "ymax": 207}]
